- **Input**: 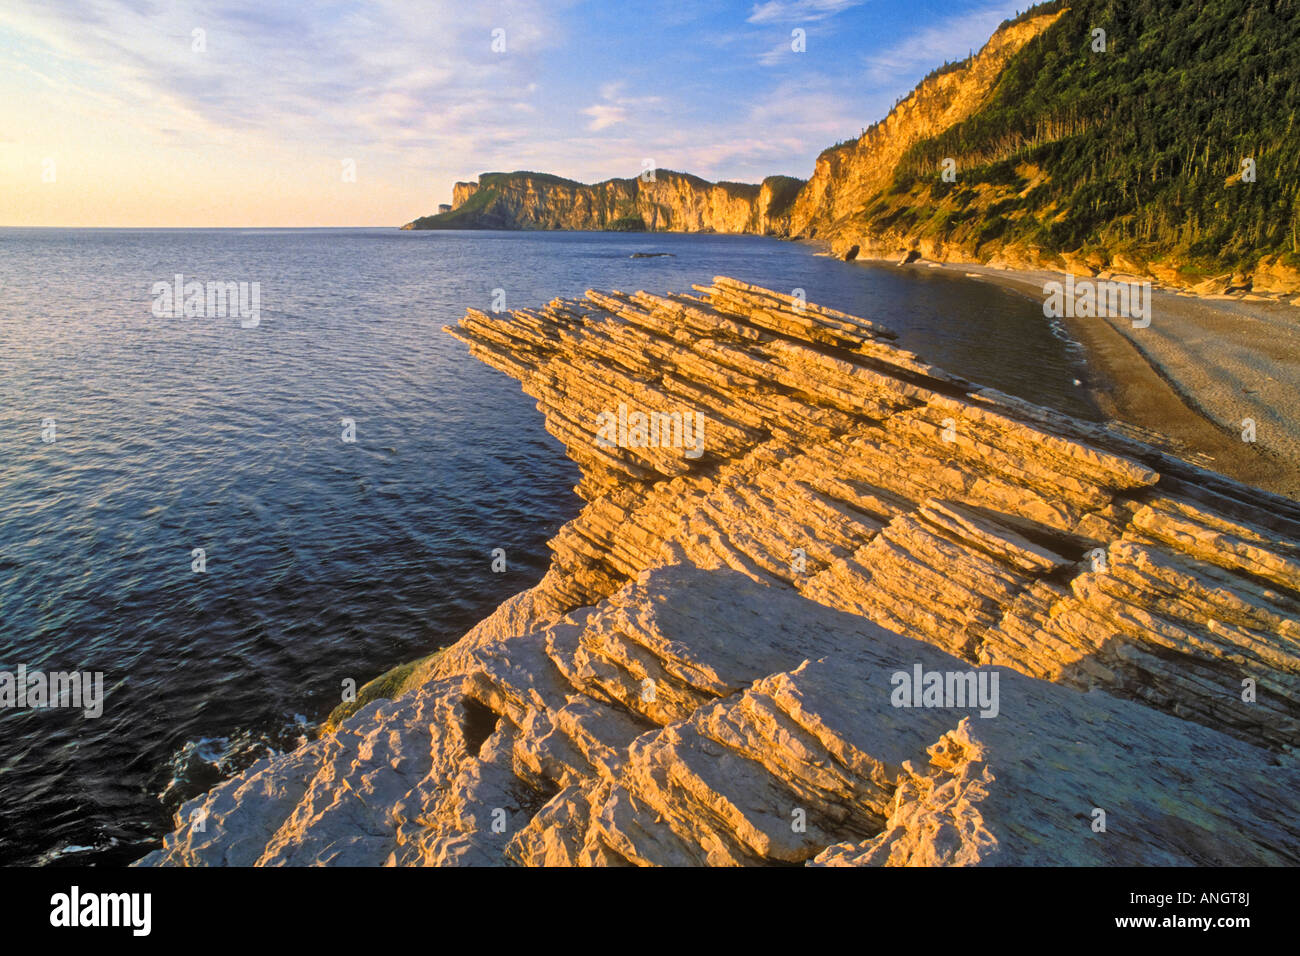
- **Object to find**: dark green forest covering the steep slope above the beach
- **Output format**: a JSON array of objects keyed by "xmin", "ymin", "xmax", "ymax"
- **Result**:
[{"xmin": 883, "ymin": 0, "xmax": 1300, "ymax": 269}]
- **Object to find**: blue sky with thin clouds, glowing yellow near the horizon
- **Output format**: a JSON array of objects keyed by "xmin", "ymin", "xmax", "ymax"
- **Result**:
[{"xmin": 0, "ymin": 0, "xmax": 1030, "ymax": 228}]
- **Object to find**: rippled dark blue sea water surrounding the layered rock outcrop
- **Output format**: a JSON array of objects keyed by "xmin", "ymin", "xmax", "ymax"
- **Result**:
[{"xmin": 0, "ymin": 229, "xmax": 1091, "ymax": 864}]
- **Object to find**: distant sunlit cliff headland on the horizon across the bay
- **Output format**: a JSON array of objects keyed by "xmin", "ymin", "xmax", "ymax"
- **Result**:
[{"xmin": 404, "ymin": 169, "xmax": 802, "ymax": 234}]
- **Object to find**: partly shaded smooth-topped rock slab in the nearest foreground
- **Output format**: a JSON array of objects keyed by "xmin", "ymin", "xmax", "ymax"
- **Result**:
[{"xmin": 143, "ymin": 566, "xmax": 1300, "ymax": 865}]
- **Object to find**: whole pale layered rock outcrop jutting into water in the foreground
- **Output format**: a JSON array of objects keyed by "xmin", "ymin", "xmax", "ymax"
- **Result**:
[{"xmin": 142, "ymin": 277, "xmax": 1300, "ymax": 865}]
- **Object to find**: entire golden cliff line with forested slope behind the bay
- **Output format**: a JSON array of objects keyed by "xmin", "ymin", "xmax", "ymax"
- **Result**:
[{"xmin": 404, "ymin": 0, "xmax": 1300, "ymax": 299}]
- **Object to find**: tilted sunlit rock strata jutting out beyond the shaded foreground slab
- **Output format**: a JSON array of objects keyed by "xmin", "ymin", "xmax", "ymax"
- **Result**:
[{"xmin": 452, "ymin": 277, "xmax": 1300, "ymax": 748}]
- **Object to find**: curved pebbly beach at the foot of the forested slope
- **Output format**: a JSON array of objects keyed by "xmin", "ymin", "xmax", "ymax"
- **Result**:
[{"xmin": 862, "ymin": 260, "xmax": 1300, "ymax": 499}]
